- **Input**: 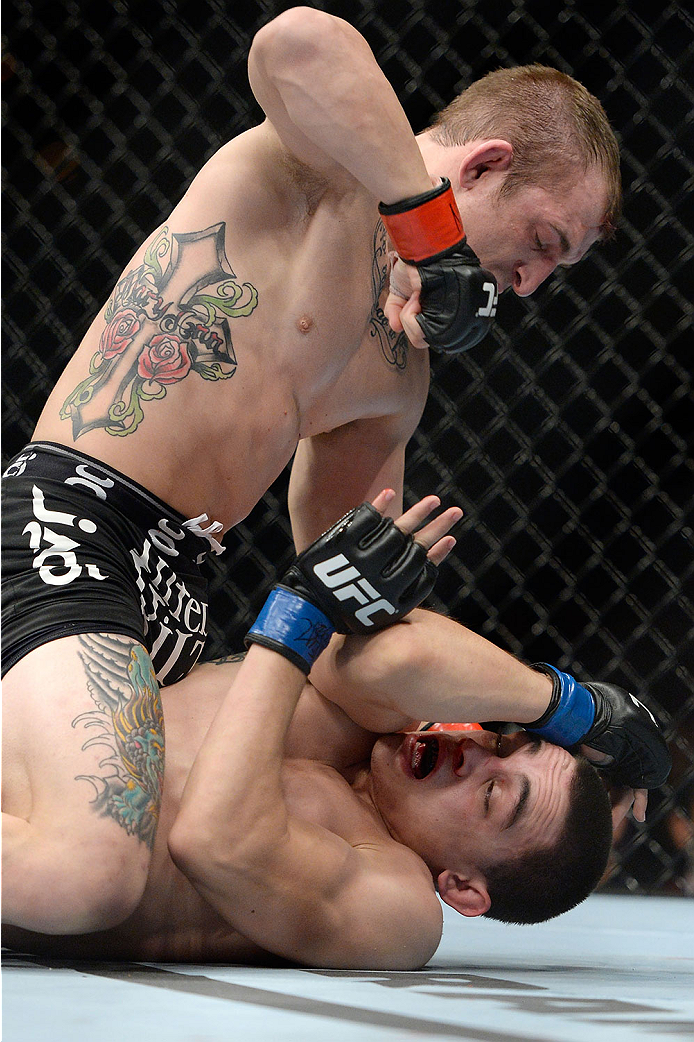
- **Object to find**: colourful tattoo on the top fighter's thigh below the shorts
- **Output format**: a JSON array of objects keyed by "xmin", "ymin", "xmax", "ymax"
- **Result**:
[{"xmin": 72, "ymin": 634, "xmax": 164, "ymax": 849}]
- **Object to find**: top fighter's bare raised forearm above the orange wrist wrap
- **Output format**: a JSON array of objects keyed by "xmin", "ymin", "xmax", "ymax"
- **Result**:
[{"xmin": 249, "ymin": 7, "xmax": 431, "ymax": 202}]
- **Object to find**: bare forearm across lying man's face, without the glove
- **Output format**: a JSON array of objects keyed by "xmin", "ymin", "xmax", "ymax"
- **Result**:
[{"xmin": 312, "ymin": 610, "xmax": 552, "ymax": 730}]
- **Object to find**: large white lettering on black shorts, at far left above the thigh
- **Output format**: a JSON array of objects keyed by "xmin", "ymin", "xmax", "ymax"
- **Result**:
[{"xmin": 22, "ymin": 485, "xmax": 108, "ymax": 586}]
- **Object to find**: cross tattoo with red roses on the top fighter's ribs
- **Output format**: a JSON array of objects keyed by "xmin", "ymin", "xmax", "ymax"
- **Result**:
[{"xmin": 60, "ymin": 222, "xmax": 257, "ymax": 440}]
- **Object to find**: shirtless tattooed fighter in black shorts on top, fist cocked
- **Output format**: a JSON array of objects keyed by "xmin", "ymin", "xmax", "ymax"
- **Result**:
[{"xmin": 2, "ymin": 8, "xmax": 666, "ymax": 950}]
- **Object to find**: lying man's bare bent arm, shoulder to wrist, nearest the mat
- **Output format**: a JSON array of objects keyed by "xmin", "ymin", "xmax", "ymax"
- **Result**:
[{"xmin": 169, "ymin": 646, "xmax": 440, "ymax": 969}]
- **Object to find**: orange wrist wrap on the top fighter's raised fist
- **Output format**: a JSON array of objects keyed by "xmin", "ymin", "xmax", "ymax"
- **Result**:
[{"xmin": 378, "ymin": 177, "xmax": 465, "ymax": 264}]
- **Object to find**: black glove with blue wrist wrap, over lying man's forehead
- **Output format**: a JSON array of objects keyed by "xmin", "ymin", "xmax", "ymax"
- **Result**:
[{"xmin": 522, "ymin": 663, "xmax": 672, "ymax": 789}]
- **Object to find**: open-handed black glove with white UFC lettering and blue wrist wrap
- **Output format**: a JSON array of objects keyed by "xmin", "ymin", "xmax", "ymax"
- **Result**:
[{"xmin": 246, "ymin": 503, "xmax": 437, "ymax": 674}]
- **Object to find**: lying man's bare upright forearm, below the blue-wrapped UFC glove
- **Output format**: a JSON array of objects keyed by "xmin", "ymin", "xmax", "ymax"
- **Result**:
[{"xmin": 170, "ymin": 646, "xmax": 305, "ymax": 869}]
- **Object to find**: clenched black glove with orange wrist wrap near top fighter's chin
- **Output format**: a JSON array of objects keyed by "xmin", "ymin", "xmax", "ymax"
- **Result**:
[{"xmin": 378, "ymin": 177, "xmax": 498, "ymax": 354}]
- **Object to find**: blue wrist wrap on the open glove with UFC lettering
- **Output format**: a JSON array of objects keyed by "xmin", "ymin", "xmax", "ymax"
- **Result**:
[{"xmin": 246, "ymin": 587, "xmax": 334, "ymax": 674}]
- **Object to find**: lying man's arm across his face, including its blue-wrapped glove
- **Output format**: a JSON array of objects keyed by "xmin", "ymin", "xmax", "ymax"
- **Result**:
[{"xmin": 312, "ymin": 611, "xmax": 671, "ymax": 808}]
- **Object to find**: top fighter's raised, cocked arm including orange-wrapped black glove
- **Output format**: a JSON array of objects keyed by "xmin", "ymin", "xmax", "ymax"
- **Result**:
[{"xmin": 248, "ymin": 7, "xmax": 497, "ymax": 353}]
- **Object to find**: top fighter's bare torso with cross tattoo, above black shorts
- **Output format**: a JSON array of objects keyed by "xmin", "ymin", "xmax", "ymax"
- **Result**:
[{"xmin": 35, "ymin": 206, "xmax": 405, "ymax": 526}]
